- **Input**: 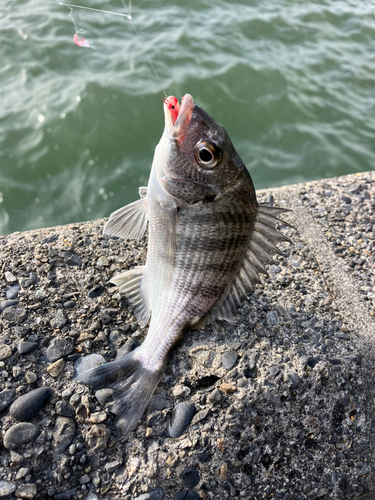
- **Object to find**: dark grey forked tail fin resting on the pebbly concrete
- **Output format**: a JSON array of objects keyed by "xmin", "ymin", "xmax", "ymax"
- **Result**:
[{"xmin": 76, "ymin": 348, "xmax": 164, "ymax": 437}]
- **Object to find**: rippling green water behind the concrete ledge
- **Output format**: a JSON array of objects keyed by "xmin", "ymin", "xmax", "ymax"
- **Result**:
[{"xmin": 0, "ymin": 0, "xmax": 375, "ymax": 233}]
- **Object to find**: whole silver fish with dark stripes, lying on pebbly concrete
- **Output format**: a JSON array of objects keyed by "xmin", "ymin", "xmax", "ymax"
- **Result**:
[{"xmin": 77, "ymin": 94, "xmax": 290, "ymax": 437}]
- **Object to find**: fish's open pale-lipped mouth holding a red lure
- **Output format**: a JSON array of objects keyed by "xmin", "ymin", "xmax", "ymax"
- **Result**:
[{"xmin": 163, "ymin": 94, "xmax": 194, "ymax": 145}]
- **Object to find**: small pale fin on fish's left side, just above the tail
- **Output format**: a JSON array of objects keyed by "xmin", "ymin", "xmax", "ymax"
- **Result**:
[{"xmin": 111, "ymin": 266, "xmax": 151, "ymax": 328}]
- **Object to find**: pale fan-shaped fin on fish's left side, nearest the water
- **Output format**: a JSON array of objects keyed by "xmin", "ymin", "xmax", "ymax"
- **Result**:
[{"xmin": 103, "ymin": 187, "xmax": 148, "ymax": 240}]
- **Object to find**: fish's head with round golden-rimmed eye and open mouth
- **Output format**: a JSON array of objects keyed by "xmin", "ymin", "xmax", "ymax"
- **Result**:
[{"xmin": 159, "ymin": 94, "xmax": 251, "ymax": 205}]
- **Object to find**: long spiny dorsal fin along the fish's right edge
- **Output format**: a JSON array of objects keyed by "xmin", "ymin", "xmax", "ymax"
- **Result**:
[{"xmin": 199, "ymin": 205, "xmax": 291, "ymax": 327}]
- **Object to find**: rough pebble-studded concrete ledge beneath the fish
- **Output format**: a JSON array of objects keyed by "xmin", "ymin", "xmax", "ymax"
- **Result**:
[{"xmin": 0, "ymin": 172, "xmax": 375, "ymax": 500}]
